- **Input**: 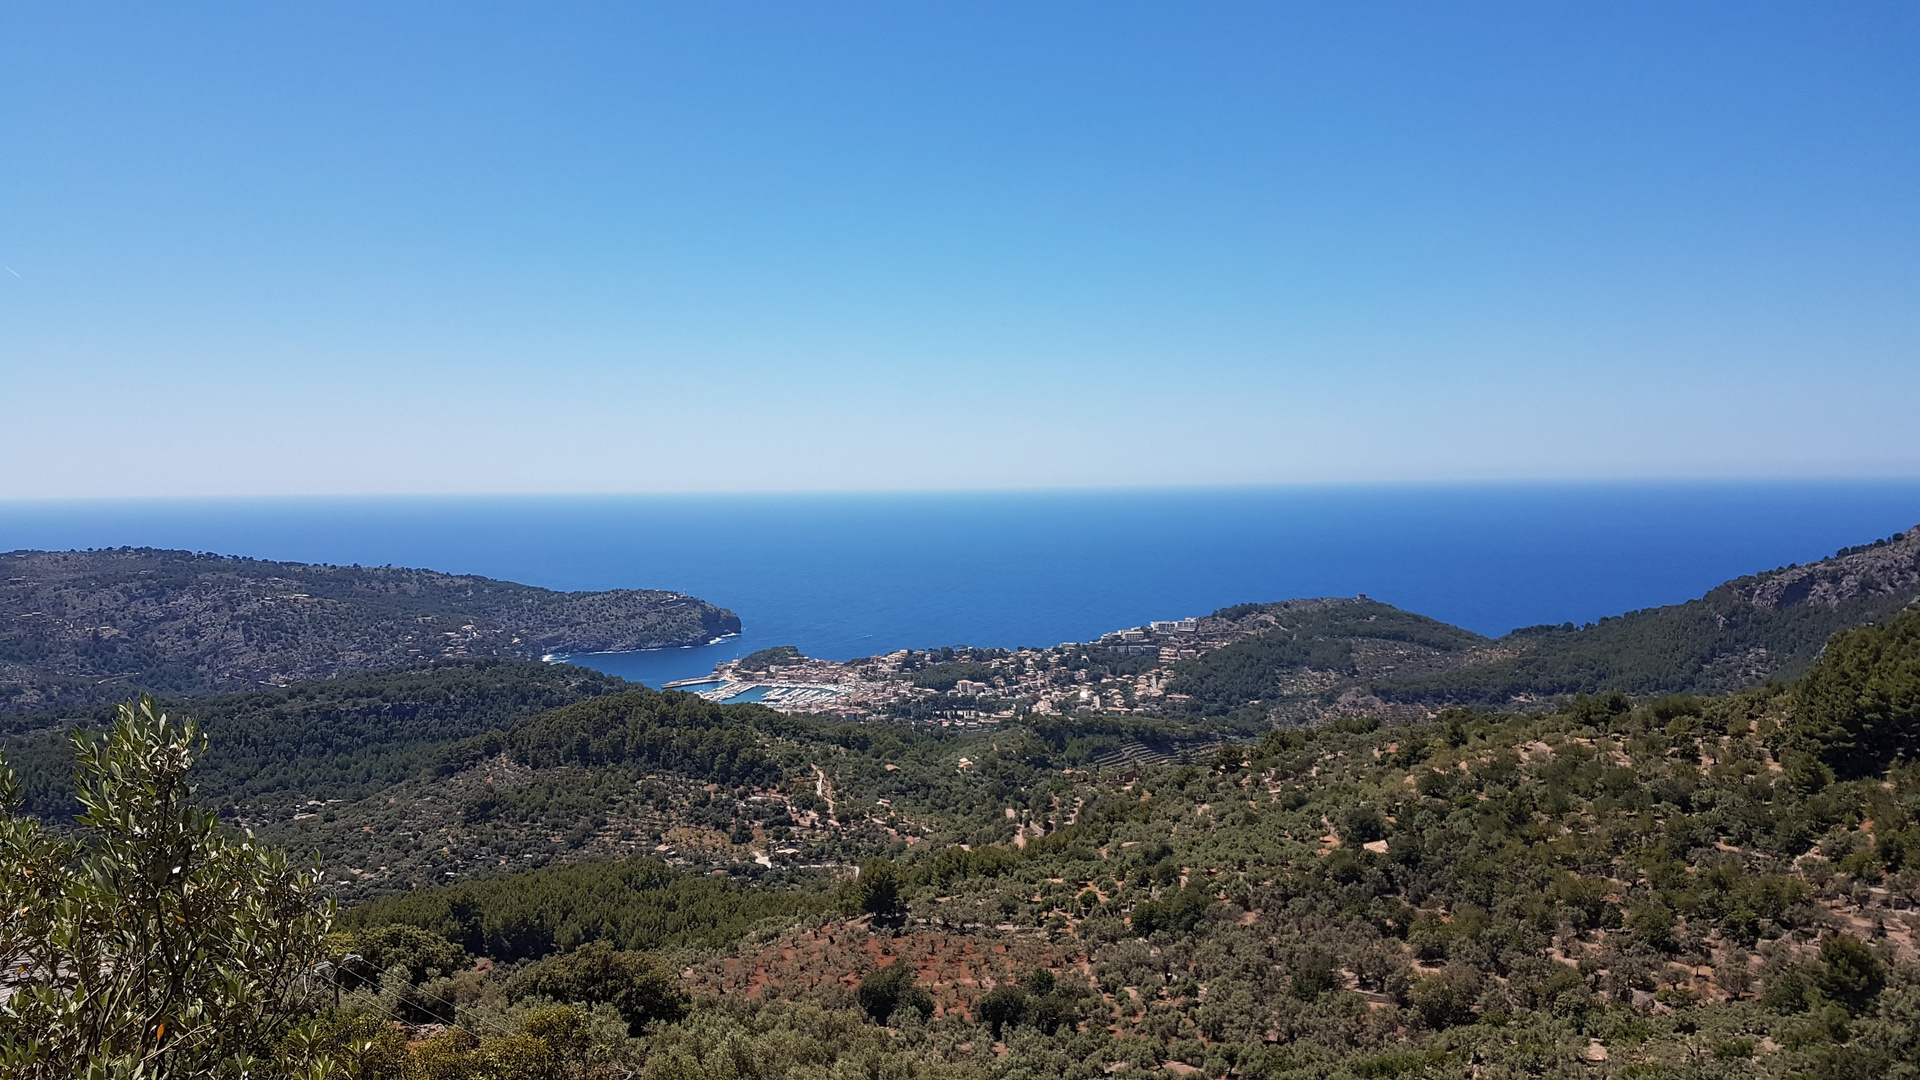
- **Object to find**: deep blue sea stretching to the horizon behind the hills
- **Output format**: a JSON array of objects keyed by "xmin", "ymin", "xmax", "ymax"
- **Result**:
[{"xmin": 0, "ymin": 480, "xmax": 1920, "ymax": 684}]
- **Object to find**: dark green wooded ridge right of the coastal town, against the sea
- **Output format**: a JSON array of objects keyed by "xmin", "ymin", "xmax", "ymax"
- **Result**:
[{"xmin": 1171, "ymin": 528, "xmax": 1920, "ymax": 713}]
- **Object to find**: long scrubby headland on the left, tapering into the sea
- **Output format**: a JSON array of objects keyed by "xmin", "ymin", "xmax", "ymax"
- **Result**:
[{"xmin": 0, "ymin": 548, "xmax": 739, "ymax": 713}]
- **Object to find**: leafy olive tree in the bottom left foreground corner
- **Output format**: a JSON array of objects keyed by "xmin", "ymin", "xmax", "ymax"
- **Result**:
[{"xmin": 0, "ymin": 698, "xmax": 332, "ymax": 1080}]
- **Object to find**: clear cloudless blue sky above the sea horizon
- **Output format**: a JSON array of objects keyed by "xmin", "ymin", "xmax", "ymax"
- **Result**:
[{"xmin": 0, "ymin": 2, "xmax": 1920, "ymax": 498}]
